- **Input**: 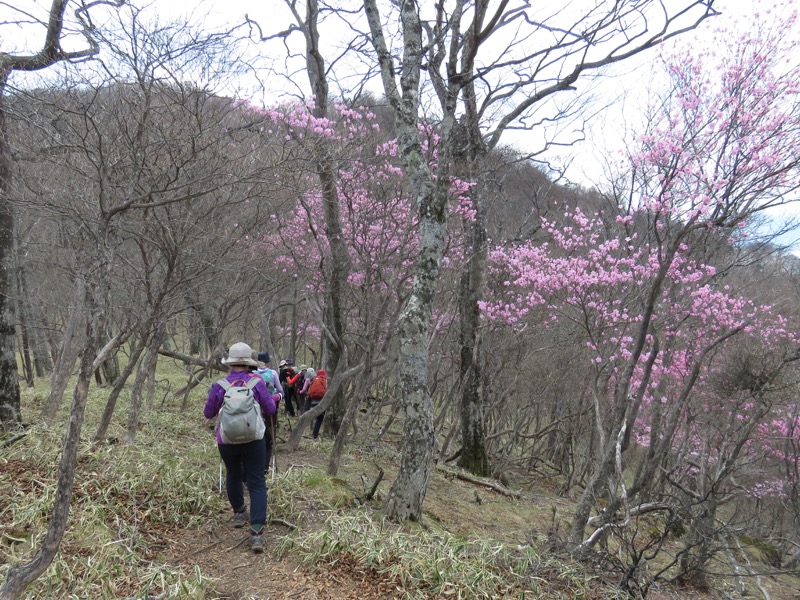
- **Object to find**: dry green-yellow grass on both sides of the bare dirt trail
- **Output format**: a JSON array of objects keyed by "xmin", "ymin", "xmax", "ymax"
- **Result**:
[{"xmin": 0, "ymin": 366, "xmax": 800, "ymax": 599}]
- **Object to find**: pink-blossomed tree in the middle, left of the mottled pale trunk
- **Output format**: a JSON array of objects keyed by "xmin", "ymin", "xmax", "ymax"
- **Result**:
[{"xmin": 227, "ymin": 102, "xmax": 406, "ymax": 367}]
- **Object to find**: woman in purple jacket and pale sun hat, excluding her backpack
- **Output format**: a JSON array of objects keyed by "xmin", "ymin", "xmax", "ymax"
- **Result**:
[{"xmin": 203, "ymin": 342, "xmax": 276, "ymax": 553}]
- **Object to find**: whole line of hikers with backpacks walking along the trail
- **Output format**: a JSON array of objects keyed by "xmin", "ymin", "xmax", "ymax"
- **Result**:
[{"xmin": 203, "ymin": 342, "xmax": 327, "ymax": 553}]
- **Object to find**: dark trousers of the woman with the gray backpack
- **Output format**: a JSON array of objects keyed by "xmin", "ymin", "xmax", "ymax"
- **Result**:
[{"xmin": 217, "ymin": 439, "xmax": 267, "ymax": 526}]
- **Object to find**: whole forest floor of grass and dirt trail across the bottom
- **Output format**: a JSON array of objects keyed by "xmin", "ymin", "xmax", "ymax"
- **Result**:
[{"xmin": 0, "ymin": 394, "xmax": 800, "ymax": 600}]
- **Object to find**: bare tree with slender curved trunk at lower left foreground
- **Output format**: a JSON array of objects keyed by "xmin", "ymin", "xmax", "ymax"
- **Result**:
[{"xmin": 0, "ymin": 3, "xmax": 284, "ymax": 598}]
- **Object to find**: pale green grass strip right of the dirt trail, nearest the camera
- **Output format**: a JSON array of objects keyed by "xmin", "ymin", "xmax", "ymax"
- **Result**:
[{"xmin": 278, "ymin": 510, "xmax": 613, "ymax": 599}]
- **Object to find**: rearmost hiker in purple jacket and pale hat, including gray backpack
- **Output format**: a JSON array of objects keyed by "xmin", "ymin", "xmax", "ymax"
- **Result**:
[{"xmin": 203, "ymin": 342, "xmax": 279, "ymax": 553}]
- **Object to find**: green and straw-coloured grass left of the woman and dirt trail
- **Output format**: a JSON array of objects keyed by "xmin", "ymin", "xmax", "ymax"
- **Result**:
[{"xmin": 0, "ymin": 380, "xmax": 222, "ymax": 599}]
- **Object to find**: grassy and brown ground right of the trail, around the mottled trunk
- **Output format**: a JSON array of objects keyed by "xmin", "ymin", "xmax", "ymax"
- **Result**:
[{"xmin": 270, "ymin": 442, "xmax": 608, "ymax": 599}]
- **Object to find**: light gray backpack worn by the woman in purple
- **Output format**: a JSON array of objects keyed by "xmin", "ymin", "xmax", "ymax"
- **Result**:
[{"xmin": 217, "ymin": 377, "xmax": 266, "ymax": 444}]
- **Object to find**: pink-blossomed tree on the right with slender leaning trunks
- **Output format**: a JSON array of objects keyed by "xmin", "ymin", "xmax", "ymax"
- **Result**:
[{"xmin": 482, "ymin": 8, "xmax": 800, "ymax": 563}]
